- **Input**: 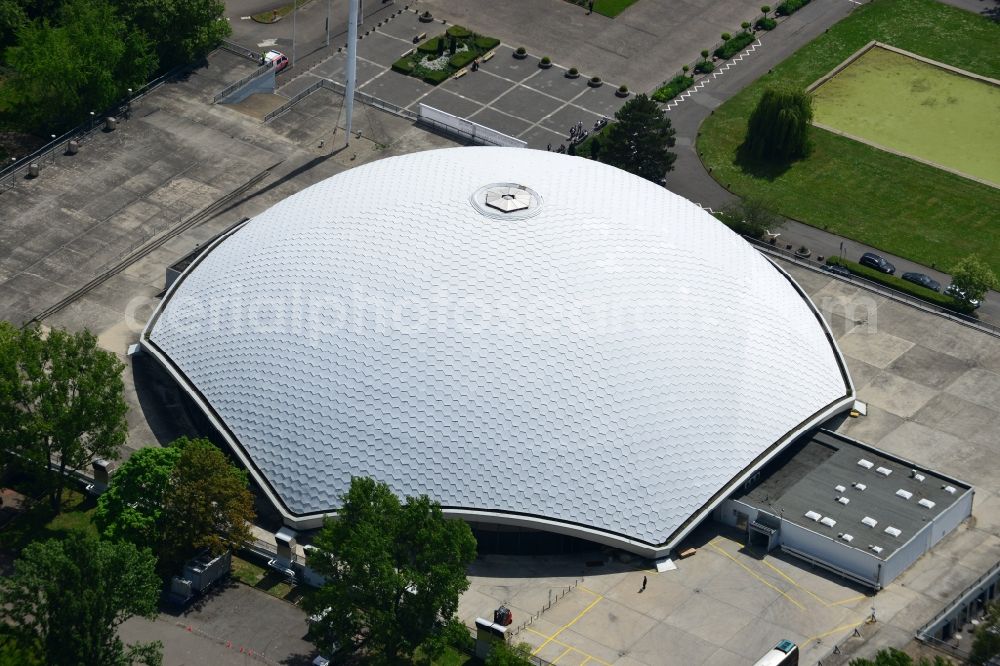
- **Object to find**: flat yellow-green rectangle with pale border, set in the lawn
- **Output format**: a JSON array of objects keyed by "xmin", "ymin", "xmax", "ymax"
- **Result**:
[{"xmin": 813, "ymin": 46, "xmax": 1000, "ymax": 187}]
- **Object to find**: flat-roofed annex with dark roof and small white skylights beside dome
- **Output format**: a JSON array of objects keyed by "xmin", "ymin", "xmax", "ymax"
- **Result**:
[{"xmin": 716, "ymin": 431, "xmax": 975, "ymax": 589}]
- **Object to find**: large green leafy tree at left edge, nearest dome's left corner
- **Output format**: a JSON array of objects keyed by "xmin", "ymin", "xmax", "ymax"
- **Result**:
[{"xmin": 0, "ymin": 322, "xmax": 128, "ymax": 511}]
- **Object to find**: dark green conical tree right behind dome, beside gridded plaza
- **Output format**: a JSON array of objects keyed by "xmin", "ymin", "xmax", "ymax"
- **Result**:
[{"xmin": 600, "ymin": 95, "xmax": 677, "ymax": 183}]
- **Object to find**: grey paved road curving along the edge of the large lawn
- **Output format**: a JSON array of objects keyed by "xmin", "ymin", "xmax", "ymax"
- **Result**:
[{"xmin": 666, "ymin": 0, "xmax": 1000, "ymax": 323}]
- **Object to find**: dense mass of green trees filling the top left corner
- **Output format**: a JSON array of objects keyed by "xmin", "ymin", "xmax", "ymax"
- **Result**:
[{"xmin": 0, "ymin": 0, "xmax": 231, "ymax": 136}]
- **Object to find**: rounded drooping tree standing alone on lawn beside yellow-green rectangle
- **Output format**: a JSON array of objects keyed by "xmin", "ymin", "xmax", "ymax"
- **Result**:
[{"xmin": 743, "ymin": 86, "xmax": 812, "ymax": 162}]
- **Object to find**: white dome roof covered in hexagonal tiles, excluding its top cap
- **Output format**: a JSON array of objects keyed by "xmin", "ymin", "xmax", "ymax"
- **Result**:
[{"xmin": 147, "ymin": 148, "xmax": 851, "ymax": 544}]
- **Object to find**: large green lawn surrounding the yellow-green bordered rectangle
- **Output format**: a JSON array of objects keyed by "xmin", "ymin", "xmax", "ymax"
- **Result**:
[{"xmin": 698, "ymin": 0, "xmax": 1000, "ymax": 273}]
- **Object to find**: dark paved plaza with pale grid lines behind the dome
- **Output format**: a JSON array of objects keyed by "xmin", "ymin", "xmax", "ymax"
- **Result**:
[{"xmin": 276, "ymin": 11, "xmax": 626, "ymax": 149}]
